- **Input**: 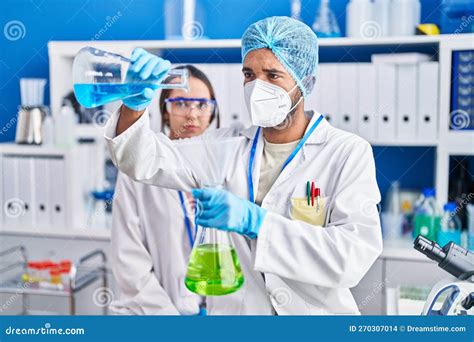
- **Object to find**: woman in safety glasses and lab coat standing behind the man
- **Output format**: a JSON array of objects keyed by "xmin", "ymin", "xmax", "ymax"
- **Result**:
[{"xmin": 111, "ymin": 65, "xmax": 219, "ymax": 315}]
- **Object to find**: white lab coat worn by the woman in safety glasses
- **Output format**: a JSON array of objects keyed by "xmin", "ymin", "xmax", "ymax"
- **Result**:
[{"xmin": 110, "ymin": 173, "xmax": 202, "ymax": 315}]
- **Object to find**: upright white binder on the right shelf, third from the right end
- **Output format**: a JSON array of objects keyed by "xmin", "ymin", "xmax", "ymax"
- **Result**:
[{"xmin": 376, "ymin": 64, "xmax": 397, "ymax": 142}]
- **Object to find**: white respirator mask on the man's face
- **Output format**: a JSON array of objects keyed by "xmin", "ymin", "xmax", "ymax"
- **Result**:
[{"xmin": 244, "ymin": 79, "xmax": 303, "ymax": 127}]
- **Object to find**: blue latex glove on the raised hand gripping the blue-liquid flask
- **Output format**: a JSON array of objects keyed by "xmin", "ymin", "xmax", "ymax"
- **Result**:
[{"xmin": 123, "ymin": 48, "xmax": 171, "ymax": 111}]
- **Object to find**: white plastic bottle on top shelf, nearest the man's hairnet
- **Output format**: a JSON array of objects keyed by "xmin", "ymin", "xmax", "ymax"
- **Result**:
[{"xmin": 346, "ymin": 0, "xmax": 376, "ymax": 38}]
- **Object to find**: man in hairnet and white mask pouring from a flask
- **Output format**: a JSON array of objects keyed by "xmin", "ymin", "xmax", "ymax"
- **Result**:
[{"xmin": 105, "ymin": 17, "xmax": 382, "ymax": 315}]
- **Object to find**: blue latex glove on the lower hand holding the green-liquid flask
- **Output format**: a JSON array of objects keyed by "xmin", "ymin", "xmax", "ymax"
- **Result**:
[{"xmin": 193, "ymin": 189, "xmax": 267, "ymax": 239}]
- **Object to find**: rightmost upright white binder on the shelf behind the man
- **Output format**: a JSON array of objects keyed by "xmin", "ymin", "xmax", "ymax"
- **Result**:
[{"xmin": 417, "ymin": 62, "xmax": 439, "ymax": 141}]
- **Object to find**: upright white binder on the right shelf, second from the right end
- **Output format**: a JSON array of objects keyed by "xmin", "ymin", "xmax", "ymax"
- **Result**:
[{"xmin": 395, "ymin": 64, "xmax": 418, "ymax": 141}]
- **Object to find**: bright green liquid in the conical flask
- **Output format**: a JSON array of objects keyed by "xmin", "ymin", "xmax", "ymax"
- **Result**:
[{"xmin": 184, "ymin": 244, "xmax": 244, "ymax": 296}]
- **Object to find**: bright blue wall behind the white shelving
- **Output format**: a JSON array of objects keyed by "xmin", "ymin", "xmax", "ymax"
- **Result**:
[{"xmin": 0, "ymin": 0, "xmax": 440, "ymax": 198}]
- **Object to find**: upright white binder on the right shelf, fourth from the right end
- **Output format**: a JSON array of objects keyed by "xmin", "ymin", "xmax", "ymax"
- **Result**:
[{"xmin": 357, "ymin": 63, "xmax": 377, "ymax": 142}]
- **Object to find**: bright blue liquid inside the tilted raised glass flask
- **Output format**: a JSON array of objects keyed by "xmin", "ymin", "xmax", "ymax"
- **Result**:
[{"xmin": 74, "ymin": 83, "xmax": 160, "ymax": 108}]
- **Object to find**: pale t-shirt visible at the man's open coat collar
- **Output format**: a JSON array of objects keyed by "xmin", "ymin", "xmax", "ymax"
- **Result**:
[{"xmin": 255, "ymin": 139, "xmax": 300, "ymax": 205}]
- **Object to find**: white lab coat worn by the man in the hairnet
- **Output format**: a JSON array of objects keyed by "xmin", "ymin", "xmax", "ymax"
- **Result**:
[{"xmin": 105, "ymin": 109, "xmax": 382, "ymax": 315}]
